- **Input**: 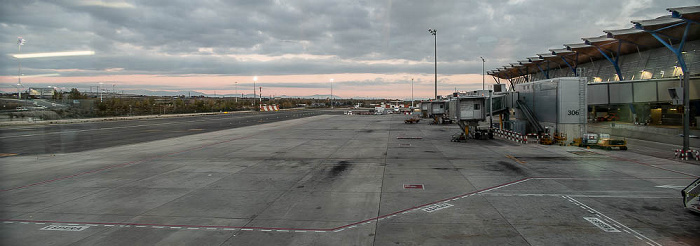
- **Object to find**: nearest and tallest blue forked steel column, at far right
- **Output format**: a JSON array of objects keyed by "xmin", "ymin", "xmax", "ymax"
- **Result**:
[{"xmin": 634, "ymin": 20, "xmax": 692, "ymax": 152}]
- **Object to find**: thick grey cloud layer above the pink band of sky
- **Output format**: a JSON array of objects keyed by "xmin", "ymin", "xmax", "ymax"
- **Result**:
[{"xmin": 0, "ymin": 0, "xmax": 697, "ymax": 83}]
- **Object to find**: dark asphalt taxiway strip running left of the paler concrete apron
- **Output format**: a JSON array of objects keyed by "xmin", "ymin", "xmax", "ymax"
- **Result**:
[{"xmin": 0, "ymin": 110, "xmax": 326, "ymax": 155}]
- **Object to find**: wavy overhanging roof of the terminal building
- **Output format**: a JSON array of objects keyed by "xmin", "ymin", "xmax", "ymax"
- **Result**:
[{"xmin": 487, "ymin": 6, "xmax": 700, "ymax": 79}]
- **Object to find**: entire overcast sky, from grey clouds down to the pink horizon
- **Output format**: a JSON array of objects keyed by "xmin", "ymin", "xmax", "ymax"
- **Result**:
[{"xmin": 0, "ymin": 0, "xmax": 700, "ymax": 98}]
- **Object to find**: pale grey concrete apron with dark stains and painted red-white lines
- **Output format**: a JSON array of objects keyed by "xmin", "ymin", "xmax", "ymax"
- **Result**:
[{"xmin": 0, "ymin": 115, "xmax": 700, "ymax": 245}]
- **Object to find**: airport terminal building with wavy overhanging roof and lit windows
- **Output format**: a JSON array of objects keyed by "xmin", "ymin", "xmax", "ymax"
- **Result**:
[{"xmin": 488, "ymin": 6, "xmax": 700, "ymax": 129}]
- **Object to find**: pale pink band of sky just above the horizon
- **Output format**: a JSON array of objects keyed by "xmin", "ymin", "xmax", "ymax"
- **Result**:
[{"xmin": 0, "ymin": 73, "xmax": 494, "ymax": 98}]
